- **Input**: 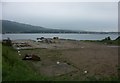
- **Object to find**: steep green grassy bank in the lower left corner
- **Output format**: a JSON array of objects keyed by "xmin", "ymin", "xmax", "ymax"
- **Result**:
[{"xmin": 2, "ymin": 45, "xmax": 48, "ymax": 81}]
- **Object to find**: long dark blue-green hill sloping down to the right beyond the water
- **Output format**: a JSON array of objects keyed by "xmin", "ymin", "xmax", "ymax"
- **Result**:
[{"xmin": 1, "ymin": 20, "xmax": 77, "ymax": 33}]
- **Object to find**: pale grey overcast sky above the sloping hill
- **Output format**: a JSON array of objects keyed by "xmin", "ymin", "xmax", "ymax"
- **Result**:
[{"xmin": 2, "ymin": 2, "xmax": 118, "ymax": 31}]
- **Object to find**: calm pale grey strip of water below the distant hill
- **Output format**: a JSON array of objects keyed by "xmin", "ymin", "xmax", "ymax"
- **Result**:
[{"xmin": 2, "ymin": 33, "xmax": 118, "ymax": 40}]
